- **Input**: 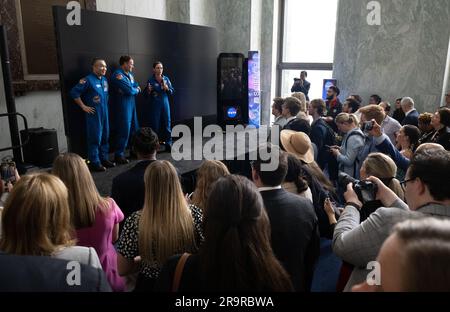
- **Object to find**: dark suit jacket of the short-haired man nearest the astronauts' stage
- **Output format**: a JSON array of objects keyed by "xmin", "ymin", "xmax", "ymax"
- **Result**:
[{"xmin": 111, "ymin": 160, "xmax": 153, "ymax": 223}]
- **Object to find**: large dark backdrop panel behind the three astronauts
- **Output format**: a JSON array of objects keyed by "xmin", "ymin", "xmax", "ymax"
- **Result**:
[{"xmin": 53, "ymin": 7, "xmax": 218, "ymax": 156}]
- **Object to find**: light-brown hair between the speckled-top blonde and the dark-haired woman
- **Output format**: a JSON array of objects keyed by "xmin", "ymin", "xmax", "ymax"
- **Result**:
[{"xmin": 192, "ymin": 160, "xmax": 230, "ymax": 210}]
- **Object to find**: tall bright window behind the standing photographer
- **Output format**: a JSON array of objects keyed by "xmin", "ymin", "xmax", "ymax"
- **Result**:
[{"xmin": 277, "ymin": 0, "xmax": 338, "ymax": 99}]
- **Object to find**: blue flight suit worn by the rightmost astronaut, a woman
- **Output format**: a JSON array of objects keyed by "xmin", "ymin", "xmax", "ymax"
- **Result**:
[{"xmin": 147, "ymin": 75, "xmax": 175, "ymax": 144}]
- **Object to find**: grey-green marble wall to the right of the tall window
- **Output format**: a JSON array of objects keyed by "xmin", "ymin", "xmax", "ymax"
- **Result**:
[{"xmin": 334, "ymin": 0, "xmax": 450, "ymax": 111}]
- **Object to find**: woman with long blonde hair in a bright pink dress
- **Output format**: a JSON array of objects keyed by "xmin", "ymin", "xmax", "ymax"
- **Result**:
[{"xmin": 53, "ymin": 153, "xmax": 125, "ymax": 291}]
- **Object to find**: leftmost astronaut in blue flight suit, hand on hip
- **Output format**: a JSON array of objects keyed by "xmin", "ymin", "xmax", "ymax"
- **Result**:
[{"xmin": 70, "ymin": 58, "xmax": 114, "ymax": 172}]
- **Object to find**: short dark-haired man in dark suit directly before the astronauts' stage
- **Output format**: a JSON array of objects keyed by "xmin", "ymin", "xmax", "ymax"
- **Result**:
[{"xmin": 111, "ymin": 128, "xmax": 159, "ymax": 223}]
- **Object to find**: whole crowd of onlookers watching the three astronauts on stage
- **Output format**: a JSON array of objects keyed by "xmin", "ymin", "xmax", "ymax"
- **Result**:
[{"xmin": 0, "ymin": 81, "xmax": 450, "ymax": 292}]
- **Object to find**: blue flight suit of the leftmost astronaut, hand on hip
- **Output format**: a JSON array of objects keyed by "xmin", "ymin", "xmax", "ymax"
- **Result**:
[{"xmin": 70, "ymin": 73, "xmax": 109, "ymax": 165}]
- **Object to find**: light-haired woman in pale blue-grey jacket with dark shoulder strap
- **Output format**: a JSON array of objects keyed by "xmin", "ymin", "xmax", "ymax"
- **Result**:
[{"xmin": 330, "ymin": 113, "xmax": 366, "ymax": 178}]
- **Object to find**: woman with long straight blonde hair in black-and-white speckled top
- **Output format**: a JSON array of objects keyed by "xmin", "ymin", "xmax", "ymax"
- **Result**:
[{"xmin": 117, "ymin": 161, "xmax": 203, "ymax": 291}]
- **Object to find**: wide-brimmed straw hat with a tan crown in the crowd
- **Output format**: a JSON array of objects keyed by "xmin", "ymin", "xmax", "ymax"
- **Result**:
[{"xmin": 280, "ymin": 130, "xmax": 314, "ymax": 164}]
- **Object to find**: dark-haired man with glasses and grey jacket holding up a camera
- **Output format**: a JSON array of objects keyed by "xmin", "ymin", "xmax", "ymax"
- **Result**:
[{"xmin": 333, "ymin": 150, "xmax": 450, "ymax": 290}]
